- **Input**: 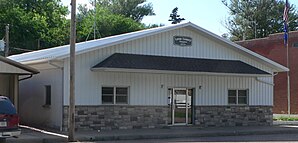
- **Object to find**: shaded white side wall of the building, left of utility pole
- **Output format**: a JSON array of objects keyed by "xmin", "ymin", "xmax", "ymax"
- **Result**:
[{"xmin": 20, "ymin": 69, "xmax": 63, "ymax": 127}]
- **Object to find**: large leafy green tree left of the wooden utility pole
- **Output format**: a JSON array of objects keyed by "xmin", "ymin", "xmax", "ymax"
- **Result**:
[{"xmin": 0, "ymin": 0, "xmax": 69, "ymax": 53}]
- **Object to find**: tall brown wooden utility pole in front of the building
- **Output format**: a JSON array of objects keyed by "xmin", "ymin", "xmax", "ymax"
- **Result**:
[{"xmin": 68, "ymin": 0, "xmax": 76, "ymax": 142}]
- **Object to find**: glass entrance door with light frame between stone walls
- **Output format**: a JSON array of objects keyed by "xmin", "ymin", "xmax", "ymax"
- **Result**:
[{"xmin": 169, "ymin": 88, "xmax": 192, "ymax": 125}]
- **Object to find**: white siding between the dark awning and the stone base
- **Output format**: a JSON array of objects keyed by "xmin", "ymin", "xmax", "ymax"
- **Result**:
[{"xmin": 64, "ymin": 72, "xmax": 273, "ymax": 105}]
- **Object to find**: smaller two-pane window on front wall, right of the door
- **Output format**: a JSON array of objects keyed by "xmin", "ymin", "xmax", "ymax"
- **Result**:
[{"xmin": 228, "ymin": 90, "xmax": 248, "ymax": 105}]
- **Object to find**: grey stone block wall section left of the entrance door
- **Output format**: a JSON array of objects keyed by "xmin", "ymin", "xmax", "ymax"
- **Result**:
[{"xmin": 63, "ymin": 105, "xmax": 169, "ymax": 131}]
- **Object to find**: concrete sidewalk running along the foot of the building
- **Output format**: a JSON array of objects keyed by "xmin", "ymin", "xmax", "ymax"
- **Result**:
[{"xmin": 6, "ymin": 125, "xmax": 298, "ymax": 143}]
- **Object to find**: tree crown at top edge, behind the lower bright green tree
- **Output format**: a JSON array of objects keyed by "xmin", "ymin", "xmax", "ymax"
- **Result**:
[{"xmin": 97, "ymin": 0, "xmax": 155, "ymax": 22}]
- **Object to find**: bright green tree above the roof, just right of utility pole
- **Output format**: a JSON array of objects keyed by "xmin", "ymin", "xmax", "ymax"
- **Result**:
[{"xmin": 77, "ymin": 5, "xmax": 145, "ymax": 42}]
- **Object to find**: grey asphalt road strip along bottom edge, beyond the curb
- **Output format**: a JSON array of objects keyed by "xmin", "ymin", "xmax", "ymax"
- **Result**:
[{"xmin": 97, "ymin": 134, "xmax": 298, "ymax": 143}]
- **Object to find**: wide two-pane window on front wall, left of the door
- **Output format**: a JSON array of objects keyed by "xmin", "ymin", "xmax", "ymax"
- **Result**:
[{"xmin": 101, "ymin": 87, "xmax": 128, "ymax": 104}]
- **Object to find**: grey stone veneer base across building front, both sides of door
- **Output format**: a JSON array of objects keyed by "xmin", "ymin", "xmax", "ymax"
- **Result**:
[{"xmin": 63, "ymin": 105, "xmax": 273, "ymax": 131}]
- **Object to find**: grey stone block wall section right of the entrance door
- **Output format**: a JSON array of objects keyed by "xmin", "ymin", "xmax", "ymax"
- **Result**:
[{"xmin": 195, "ymin": 106, "xmax": 273, "ymax": 127}]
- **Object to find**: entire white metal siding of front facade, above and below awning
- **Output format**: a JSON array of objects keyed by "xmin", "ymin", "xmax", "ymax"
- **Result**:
[{"xmin": 64, "ymin": 28, "xmax": 273, "ymax": 105}]
